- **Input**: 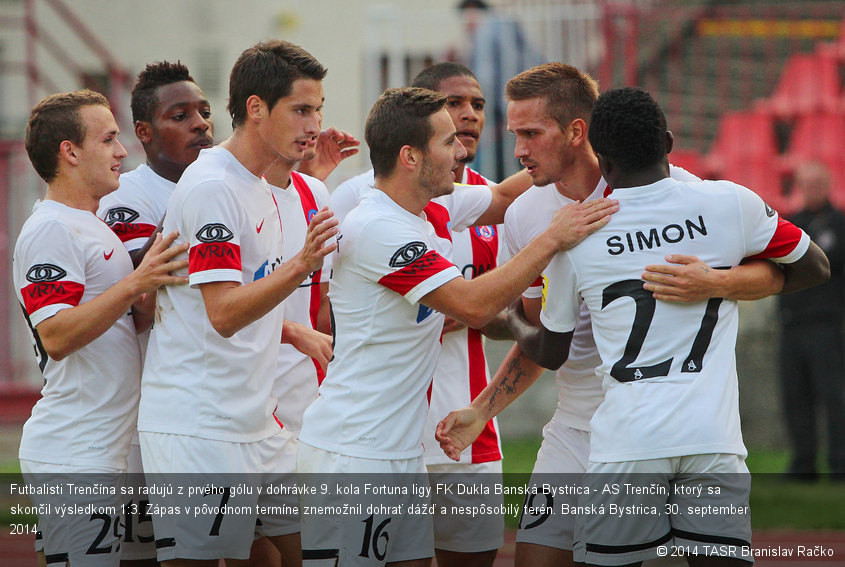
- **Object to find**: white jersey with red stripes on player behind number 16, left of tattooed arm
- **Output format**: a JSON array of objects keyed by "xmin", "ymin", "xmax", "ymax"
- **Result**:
[{"xmin": 423, "ymin": 167, "xmax": 504, "ymax": 465}]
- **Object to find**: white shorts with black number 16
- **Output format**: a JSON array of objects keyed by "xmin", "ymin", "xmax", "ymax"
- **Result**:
[{"xmin": 297, "ymin": 443, "xmax": 434, "ymax": 567}]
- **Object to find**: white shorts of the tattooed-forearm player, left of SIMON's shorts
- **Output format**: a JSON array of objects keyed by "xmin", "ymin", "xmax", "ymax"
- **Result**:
[{"xmin": 516, "ymin": 420, "xmax": 590, "ymax": 551}]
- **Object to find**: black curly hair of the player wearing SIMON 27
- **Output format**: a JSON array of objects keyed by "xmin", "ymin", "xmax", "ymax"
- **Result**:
[{"xmin": 588, "ymin": 87, "xmax": 667, "ymax": 171}]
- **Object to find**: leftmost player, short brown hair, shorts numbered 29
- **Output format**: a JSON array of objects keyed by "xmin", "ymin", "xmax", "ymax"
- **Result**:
[{"xmin": 13, "ymin": 90, "xmax": 187, "ymax": 566}]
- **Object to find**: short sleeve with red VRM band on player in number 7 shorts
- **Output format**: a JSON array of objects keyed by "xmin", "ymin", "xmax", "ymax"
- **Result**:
[{"xmin": 177, "ymin": 181, "xmax": 244, "ymax": 286}]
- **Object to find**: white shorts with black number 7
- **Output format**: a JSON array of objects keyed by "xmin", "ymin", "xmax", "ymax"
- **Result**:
[{"xmin": 140, "ymin": 430, "xmax": 299, "ymax": 561}]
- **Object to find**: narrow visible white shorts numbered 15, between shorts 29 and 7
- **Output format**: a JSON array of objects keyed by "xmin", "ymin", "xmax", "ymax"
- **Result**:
[{"xmin": 120, "ymin": 442, "xmax": 156, "ymax": 561}]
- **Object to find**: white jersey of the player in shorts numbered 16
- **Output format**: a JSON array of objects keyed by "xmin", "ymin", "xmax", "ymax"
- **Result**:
[{"xmin": 300, "ymin": 190, "xmax": 462, "ymax": 459}]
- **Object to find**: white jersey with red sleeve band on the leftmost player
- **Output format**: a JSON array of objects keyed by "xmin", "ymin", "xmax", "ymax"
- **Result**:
[{"xmin": 13, "ymin": 200, "xmax": 141, "ymax": 469}]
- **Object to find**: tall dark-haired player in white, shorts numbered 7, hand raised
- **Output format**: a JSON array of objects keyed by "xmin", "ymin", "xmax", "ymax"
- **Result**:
[{"xmin": 138, "ymin": 41, "xmax": 337, "ymax": 565}]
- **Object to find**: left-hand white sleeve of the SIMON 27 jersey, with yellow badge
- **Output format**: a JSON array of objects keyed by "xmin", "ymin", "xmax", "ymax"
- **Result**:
[{"xmin": 540, "ymin": 252, "xmax": 581, "ymax": 333}]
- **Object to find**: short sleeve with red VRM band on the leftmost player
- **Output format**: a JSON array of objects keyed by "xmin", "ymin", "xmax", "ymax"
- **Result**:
[{"xmin": 14, "ymin": 221, "xmax": 85, "ymax": 326}]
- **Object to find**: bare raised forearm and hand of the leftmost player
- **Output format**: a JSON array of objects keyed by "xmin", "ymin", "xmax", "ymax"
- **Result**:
[{"xmin": 37, "ymin": 232, "xmax": 188, "ymax": 360}]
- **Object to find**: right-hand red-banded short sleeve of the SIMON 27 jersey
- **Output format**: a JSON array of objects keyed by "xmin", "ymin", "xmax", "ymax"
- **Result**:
[{"xmin": 734, "ymin": 184, "xmax": 810, "ymax": 264}]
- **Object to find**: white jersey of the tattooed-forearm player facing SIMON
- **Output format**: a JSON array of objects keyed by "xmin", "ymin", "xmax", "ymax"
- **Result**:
[{"xmin": 505, "ymin": 166, "xmax": 700, "ymax": 431}]
